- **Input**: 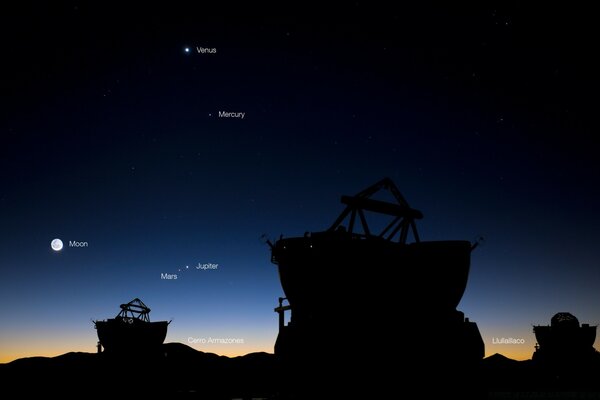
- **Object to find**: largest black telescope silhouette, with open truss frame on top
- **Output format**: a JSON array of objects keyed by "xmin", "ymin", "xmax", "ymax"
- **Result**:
[{"xmin": 268, "ymin": 178, "xmax": 484, "ymax": 394}]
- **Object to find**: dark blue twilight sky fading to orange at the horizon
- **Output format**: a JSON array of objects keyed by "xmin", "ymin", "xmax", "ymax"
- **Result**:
[{"xmin": 0, "ymin": 1, "xmax": 600, "ymax": 362}]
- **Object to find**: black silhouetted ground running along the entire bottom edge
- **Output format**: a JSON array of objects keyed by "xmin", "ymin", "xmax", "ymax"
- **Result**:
[{"xmin": 0, "ymin": 343, "xmax": 600, "ymax": 399}]
